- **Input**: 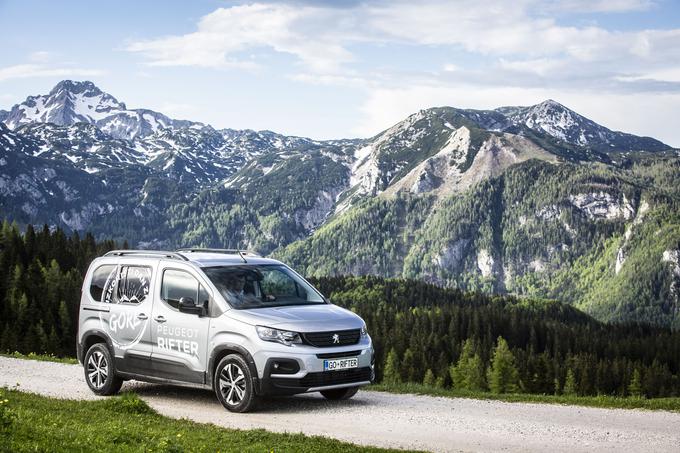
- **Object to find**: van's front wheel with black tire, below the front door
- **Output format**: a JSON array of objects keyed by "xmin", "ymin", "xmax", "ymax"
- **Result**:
[{"xmin": 213, "ymin": 354, "xmax": 257, "ymax": 412}]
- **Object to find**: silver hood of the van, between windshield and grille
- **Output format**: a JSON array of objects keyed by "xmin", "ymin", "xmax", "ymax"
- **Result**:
[{"xmin": 226, "ymin": 304, "xmax": 364, "ymax": 332}]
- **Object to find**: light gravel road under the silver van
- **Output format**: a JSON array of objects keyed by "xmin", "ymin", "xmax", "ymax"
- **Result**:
[{"xmin": 0, "ymin": 357, "xmax": 680, "ymax": 452}]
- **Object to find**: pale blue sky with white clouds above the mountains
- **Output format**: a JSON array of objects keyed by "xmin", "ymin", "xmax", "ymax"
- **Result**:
[{"xmin": 0, "ymin": 0, "xmax": 680, "ymax": 147}]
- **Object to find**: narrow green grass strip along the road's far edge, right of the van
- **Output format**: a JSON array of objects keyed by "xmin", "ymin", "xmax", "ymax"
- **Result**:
[{"xmin": 368, "ymin": 383, "xmax": 680, "ymax": 412}]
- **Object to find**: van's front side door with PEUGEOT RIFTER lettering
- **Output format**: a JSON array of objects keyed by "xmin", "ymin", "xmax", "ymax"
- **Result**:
[{"xmin": 151, "ymin": 265, "xmax": 210, "ymax": 384}]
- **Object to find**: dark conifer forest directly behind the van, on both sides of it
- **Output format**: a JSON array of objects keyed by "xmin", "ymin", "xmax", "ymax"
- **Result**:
[{"xmin": 0, "ymin": 222, "xmax": 680, "ymax": 398}]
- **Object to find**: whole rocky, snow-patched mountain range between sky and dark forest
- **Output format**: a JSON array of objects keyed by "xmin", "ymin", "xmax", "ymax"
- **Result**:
[{"xmin": 0, "ymin": 81, "xmax": 680, "ymax": 327}]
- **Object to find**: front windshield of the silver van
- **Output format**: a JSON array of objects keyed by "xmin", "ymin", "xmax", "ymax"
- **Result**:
[{"xmin": 203, "ymin": 264, "xmax": 326, "ymax": 309}]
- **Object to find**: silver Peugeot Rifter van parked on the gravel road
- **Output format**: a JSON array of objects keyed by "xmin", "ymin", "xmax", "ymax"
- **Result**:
[{"xmin": 77, "ymin": 249, "xmax": 375, "ymax": 412}]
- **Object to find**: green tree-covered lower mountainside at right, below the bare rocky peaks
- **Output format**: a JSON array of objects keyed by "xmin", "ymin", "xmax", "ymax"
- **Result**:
[{"xmin": 275, "ymin": 160, "xmax": 680, "ymax": 327}]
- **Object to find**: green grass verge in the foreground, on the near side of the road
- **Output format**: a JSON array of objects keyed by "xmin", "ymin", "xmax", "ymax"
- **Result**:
[{"xmin": 0, "ymin": 389, "xmax": 414, "ymax": 453}]
